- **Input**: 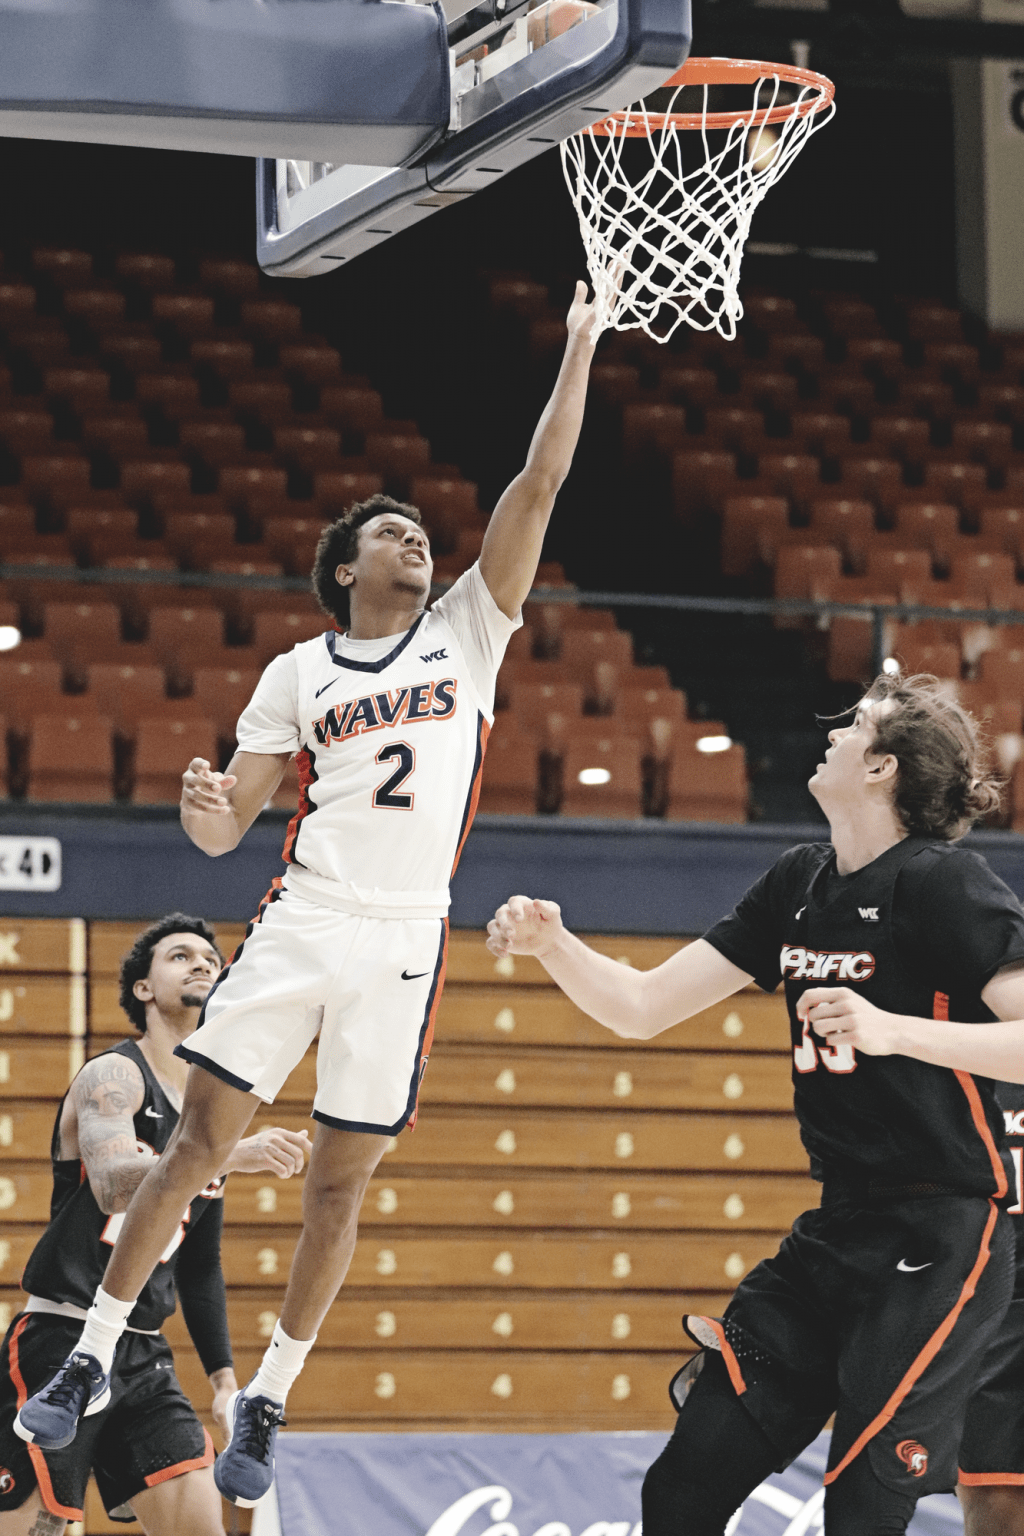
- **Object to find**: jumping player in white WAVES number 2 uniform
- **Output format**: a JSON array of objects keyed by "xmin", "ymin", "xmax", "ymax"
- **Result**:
[{"xmin": 21, "ymin": 283, "xmax": 594, "ymax": 1505}]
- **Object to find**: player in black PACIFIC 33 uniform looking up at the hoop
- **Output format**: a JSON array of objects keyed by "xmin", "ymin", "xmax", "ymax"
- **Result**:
[{"xmin": 488, "ymin": 677, "xmax": 1024, "ymax": 1536}]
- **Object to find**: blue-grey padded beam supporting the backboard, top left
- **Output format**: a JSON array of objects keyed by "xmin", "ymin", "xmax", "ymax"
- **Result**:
[{"xmin": 0, "ymin": 0, "xmax": 450, "ymax": 166}]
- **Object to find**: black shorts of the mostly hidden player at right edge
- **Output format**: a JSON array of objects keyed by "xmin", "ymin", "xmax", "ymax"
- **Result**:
[{"xmin": 960, "ymin": 1286, "xmax": 1024, "ymax": 1487}]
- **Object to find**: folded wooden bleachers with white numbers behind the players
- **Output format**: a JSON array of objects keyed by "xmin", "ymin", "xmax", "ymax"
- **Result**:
[{"xmin": 0, "ymin": 920, "xmax": 817, "ymax": 1536}]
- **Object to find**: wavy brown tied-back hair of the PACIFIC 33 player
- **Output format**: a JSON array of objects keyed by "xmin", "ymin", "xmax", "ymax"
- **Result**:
[{"xmin": 864, "ymin": 673, "xmax": 1001, "ymax": 842}]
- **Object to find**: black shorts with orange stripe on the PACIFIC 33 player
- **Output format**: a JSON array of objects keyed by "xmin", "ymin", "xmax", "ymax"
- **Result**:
[{"xmin": 681, "ymin": 1195, "xmax": 1015, "ymax": 1498}]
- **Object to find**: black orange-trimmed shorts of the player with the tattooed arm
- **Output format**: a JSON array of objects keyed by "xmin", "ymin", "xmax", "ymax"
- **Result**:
[{"xmin": 0, "ymin": 1312, "xmax": 213, "ymax": 1521}]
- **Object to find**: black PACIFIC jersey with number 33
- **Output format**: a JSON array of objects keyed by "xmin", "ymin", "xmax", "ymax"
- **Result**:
[{"xmin": 706, "ymin": 837, "xmax": 1024, "ymax": 1197}]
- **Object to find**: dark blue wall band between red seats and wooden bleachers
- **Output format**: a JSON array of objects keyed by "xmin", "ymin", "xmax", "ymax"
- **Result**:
[{"xmin": 0, "ymin": 800, "xmax": 1024, "ymax": 934}]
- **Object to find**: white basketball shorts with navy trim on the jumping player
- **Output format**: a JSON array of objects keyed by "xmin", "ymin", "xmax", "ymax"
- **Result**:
[{"xmin": 175, "ymin": 889, "xmax": 448, "ymax": 1135}]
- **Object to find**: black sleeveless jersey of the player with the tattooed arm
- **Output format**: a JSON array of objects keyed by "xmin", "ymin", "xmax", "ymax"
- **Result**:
[{"xmin": 21, "ymin": 1040, "xmax": 224, "ymax": 1330}]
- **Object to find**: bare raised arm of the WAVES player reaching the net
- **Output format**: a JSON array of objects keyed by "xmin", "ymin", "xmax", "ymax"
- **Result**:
[{"xmin": 481, "ymin": 283, "xmax": 594, "ymax": 619}]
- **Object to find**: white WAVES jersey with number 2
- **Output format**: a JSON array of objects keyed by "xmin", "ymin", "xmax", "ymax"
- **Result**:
[{"xmin": 238, "ymin": 571, "xmax": 516, "ymax": 917}]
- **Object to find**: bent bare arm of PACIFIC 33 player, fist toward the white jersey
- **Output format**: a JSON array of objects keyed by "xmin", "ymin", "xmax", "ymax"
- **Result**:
[{"xmin": 487, "ymin": 895, "xmax": 751, "ymax": 1040}]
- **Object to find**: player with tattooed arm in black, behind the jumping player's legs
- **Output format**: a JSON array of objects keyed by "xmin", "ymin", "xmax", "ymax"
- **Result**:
[{"xmin": 0, "ymin": 912, "xmax": 307, "ymax": 1536}]
